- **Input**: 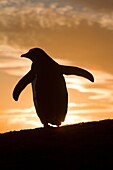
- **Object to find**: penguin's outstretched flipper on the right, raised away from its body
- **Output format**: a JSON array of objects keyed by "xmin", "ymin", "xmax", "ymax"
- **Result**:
[{"xmin": 60, "ymin": 65, "xmax": 94, "ymax": 82}]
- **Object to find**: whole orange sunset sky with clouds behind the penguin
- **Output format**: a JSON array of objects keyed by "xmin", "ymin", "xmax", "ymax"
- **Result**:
[{"xmin": 0, "ymin": 0, "xmax": 113, "ymax": 133}]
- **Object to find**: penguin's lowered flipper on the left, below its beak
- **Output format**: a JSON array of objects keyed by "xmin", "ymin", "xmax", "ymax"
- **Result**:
[{"xmin": 13, "ymin": 70, "xmax": 35, "ymax": 101}]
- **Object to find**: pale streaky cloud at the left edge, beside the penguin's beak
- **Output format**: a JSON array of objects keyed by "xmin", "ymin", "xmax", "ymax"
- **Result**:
[{"xmin": 0, "ymin": 44, "xmax": 31, "ymax": 76}]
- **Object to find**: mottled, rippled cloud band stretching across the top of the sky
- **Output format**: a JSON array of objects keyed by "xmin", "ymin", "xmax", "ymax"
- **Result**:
[{"xmin": 0, "ymin": 0, "xmax": 113, "ymax": 35}]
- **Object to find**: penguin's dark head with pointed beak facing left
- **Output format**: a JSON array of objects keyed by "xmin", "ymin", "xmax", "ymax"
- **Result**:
[{"xmin": 21, "ymin": 48, "xmax": 47, "ymax": 62}]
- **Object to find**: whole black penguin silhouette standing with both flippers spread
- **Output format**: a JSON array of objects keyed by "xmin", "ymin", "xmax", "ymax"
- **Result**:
[{"xmin": 13, "ymin": 48, "xmax": 94, "ymax": 127}]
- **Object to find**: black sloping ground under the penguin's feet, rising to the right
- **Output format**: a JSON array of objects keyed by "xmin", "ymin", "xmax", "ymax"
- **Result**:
[{"xmin": 0, "ymin": 120, "xmax": 113, "ymax": 170}]
